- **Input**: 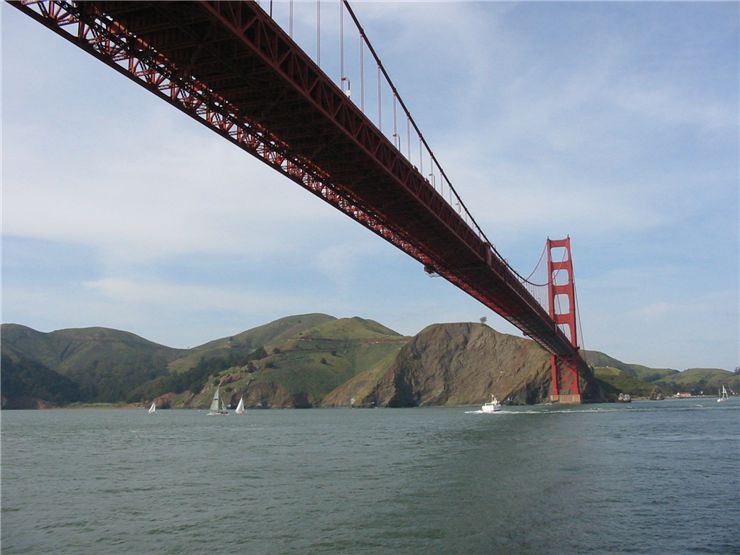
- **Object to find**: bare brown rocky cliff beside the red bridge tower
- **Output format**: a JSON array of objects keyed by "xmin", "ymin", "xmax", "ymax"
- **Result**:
[{"xmin": 324, "ymin": 323, "xmax": 600, "ymax": 407}]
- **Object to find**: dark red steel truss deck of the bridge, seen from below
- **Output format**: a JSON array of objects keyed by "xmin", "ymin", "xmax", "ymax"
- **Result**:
[{"xmin": 14, "ymin": 0, "xmax": 577, "ymax": 364}]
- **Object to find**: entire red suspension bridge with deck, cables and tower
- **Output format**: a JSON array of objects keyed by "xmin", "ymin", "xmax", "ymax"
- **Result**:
[{"xmin": 11, "ymin": 0, "xmax": 583, "ymax": 402}]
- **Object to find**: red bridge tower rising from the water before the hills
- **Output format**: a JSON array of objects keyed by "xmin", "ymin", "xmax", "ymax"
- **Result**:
[{"xmin": 547, "ymin": 237, "xmax": 581, "ymax": 404}]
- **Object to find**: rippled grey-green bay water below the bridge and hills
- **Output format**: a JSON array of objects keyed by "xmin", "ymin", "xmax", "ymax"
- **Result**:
[{"xmin": 2, "ymin": 398, "xmax": 740, "ymax": 554}]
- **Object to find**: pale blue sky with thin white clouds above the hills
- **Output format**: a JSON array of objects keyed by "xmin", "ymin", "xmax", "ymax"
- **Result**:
[{"xmin": 1, "ymin": 2, "xmax": 740, "ymax": 370}]
